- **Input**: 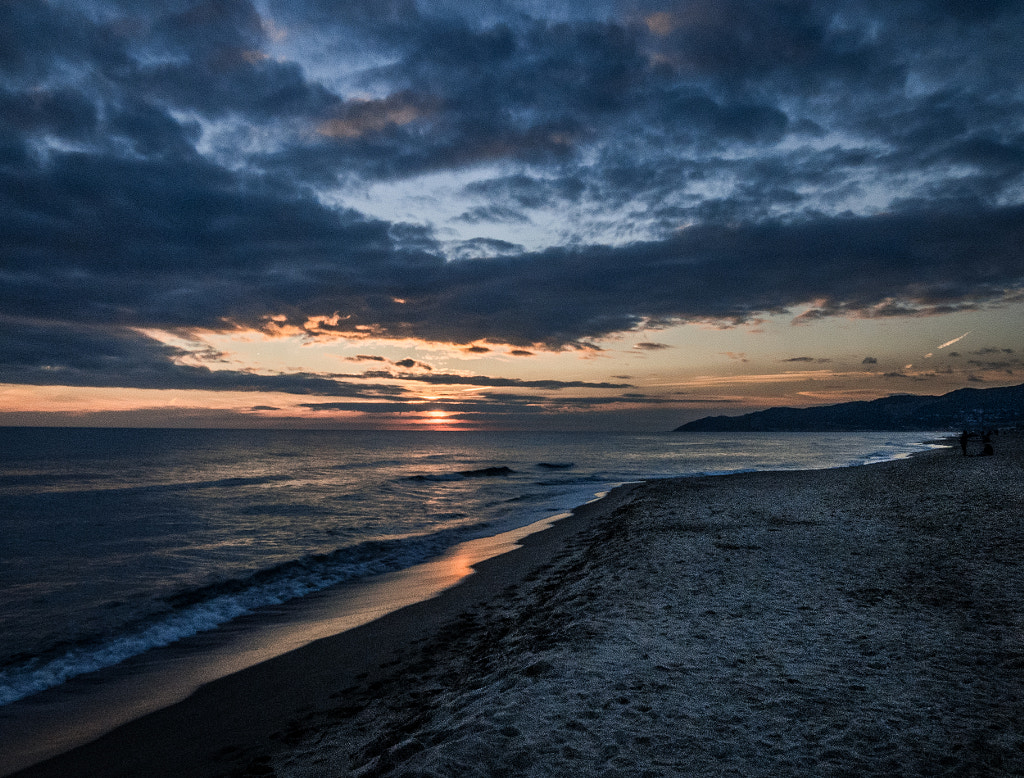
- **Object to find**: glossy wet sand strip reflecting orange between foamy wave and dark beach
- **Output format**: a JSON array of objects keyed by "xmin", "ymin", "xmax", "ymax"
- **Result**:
[{"xmin": 0, "ymin": 492, "xmax": 607, "ymax": 776}]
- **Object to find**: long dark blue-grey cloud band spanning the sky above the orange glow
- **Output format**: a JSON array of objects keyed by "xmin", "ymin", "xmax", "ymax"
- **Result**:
[{"xmin": 6, "ymin": 184, "xmax": 1024, "ymax": 348}]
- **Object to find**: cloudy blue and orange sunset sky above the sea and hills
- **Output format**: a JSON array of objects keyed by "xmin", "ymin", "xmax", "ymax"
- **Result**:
[{"xmin": 0, "ymin": 0, "xmax": 1024, "ymax": 431}]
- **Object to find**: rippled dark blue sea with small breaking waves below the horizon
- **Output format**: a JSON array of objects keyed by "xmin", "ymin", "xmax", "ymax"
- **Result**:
[{"xmin": 0, "ymin": 428, "xmax": 935, "ymax": 704}]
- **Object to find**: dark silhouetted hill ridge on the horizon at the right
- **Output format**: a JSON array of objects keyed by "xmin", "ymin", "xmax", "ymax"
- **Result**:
[{"xmin": 675, "ymin": 384, "xmax": 1024, "ymax": 432}]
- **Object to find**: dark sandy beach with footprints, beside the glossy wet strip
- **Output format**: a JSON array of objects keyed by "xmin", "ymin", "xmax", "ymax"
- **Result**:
[{"xmin": 14, "ymin": 435, "xmax": 1024, "ymax": 777}]
